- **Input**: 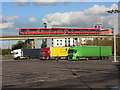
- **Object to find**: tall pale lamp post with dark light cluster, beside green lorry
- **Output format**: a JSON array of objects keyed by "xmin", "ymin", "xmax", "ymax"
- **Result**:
[{"xmin": 107, "ymin": 9, "xmax": 120, "ymax": 62}]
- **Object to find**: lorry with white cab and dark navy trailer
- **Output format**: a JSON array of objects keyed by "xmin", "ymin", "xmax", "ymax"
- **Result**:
[{"xmin": 11, "ymin": 49, "xmax": 40, "ymax": 60}]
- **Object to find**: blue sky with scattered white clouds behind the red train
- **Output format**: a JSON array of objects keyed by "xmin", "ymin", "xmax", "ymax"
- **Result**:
[{"xmin": 0, "ymin": 0, "xmax": 118, "ymax": 48}]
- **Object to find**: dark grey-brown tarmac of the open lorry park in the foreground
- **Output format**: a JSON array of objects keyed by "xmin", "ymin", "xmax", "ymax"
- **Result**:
[{"xmin": 0, "ymin": 59, "xmax": 120, "ymax": 90}]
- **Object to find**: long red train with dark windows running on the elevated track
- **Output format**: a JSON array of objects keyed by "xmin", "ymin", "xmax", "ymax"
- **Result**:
[{"xmin": 19, "ymin": 28, "xmax": 101, "ymax": 35}]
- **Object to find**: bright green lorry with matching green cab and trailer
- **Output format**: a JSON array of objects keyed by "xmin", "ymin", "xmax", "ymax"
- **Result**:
[{"xmin": 68, "ymin": 46, "xmax": 112, "ymax": 60}]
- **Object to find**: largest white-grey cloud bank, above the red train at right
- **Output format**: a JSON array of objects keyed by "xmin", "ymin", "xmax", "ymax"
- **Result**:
[{"xmin": 42, "ymin": 4, "xmax": 118, "ymax": 27}]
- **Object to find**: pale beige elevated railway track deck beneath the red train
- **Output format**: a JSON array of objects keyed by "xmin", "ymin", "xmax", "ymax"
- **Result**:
[{"xmin": 0, "ymin": 34, "xmax": 120, "ymax": 40}]
